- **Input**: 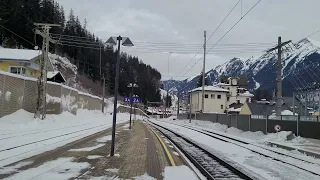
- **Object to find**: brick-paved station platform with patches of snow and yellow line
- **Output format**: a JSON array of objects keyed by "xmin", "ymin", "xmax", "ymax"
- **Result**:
[{"xmin": 0, "ymin": 121, "xmax": 192, "ymax": 179}]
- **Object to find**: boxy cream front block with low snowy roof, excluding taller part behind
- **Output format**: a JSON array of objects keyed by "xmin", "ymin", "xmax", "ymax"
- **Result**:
[{"xmin": 189, "ymin": 86, "xmax": 229, "ymax": 113}]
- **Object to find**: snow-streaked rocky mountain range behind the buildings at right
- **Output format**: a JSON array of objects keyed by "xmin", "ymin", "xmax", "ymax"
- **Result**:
[{"xmin": 163, "ymin": 38, "xmax": 320, "ymax": 96}]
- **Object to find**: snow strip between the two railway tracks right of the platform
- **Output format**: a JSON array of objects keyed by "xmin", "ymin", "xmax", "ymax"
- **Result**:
[{"xmin": 152, "ymin": 120, "xmax": 320, "ymax": 180}]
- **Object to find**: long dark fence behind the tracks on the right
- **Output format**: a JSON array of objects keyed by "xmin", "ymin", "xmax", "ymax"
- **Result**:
[{"xmin": 177, "ymin": 113, "xmax": 320, "ymax": 139}]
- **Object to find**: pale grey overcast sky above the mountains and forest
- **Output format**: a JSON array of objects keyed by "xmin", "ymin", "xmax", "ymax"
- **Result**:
[{"xmin": 57, "ymin": 0, "xmax": 320, "ymax": 79}]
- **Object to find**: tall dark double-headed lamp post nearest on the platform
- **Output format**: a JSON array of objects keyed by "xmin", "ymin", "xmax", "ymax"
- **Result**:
[{"xmin": 106, "ymin": 36, "xmax": 134, "ymax": 156}]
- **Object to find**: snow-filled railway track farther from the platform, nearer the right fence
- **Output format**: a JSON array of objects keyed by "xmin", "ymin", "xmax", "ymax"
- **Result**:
[{"xmin": 156, "ymin": 122, "xmax": 320, "ymax": 178}]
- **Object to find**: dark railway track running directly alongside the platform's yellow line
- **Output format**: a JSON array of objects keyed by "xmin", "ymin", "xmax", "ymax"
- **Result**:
[{"xmin": 148, "ymin": 121, "xmax": 257, "ymax": 180}]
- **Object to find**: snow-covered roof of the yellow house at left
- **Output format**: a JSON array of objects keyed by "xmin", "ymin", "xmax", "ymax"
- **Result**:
[{"xmin": 0, "ymin": 48, "xmax": 42, "ymax": 61}]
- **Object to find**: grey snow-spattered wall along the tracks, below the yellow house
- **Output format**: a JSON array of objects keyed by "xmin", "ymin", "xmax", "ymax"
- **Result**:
[{"xmin": 0, "ymin": 72, "xmax": 107, "ymax": 117}]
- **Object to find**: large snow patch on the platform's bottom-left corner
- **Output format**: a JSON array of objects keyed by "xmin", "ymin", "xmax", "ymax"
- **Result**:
[{"xmin": 7, "ymin": 158, "xmax": 90, "ymax": 180}]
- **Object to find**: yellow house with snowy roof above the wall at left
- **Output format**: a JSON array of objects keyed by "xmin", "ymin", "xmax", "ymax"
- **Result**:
[{"xmin": 0, "ymin": 48, "xmax": 54, "ymax": 78}]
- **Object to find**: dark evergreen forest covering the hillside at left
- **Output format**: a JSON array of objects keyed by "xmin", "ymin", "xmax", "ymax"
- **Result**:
[{"xmin": 0, "ymin": 0, "xmax": 161, "ymax": 104}]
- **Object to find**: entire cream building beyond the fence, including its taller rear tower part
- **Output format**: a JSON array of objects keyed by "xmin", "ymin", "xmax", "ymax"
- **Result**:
[{"xmin": 189, "ymin": 77, "xmax": 253, "ymax": 113}]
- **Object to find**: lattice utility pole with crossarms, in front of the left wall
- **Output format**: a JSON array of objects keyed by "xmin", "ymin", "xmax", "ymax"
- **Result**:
[{"xmin": 34, "ymin": 23, "xmax": 60, "ymax": 119}]
